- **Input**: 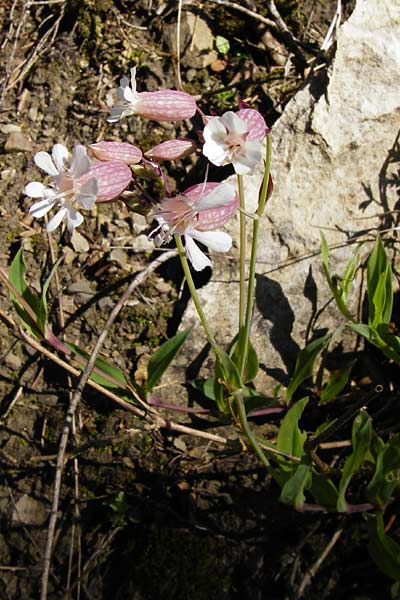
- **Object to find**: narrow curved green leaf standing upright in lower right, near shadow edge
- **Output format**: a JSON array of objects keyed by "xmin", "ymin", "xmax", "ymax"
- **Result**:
[{"xmin": 337, "ymin": 410, "xmax": 372, "ymax": 512}]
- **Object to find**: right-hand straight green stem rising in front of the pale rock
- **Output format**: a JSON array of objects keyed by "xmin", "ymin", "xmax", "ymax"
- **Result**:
[{"xmin": 239, "ymin": 133, "xmax": 271, "ymax": 377}]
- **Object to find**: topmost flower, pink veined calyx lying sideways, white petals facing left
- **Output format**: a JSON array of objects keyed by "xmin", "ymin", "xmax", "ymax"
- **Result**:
[{"xmin": 107, "ymin": 67, "xmax": 197, "ymax": 123}]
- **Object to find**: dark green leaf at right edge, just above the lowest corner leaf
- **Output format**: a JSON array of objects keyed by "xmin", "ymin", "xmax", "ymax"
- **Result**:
[{"xmin": 367, "ymin": 433, "xmax": 400, "ymax": 506}]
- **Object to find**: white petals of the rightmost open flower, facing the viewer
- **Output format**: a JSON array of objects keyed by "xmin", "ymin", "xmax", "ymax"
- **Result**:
[{"xmin": 203, "ymin": 111, "xmax": 263, "ymax": 175}]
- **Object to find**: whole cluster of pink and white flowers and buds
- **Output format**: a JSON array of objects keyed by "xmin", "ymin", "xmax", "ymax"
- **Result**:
[{"xmin": 24, "ymin": 68, "xmax": 268, "ymax": 271}]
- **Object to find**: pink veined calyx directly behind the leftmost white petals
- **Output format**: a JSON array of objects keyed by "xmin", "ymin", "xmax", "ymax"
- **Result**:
[{"xmin": 79, "ymin": 161, "xmax": 132, "ymax": 203}]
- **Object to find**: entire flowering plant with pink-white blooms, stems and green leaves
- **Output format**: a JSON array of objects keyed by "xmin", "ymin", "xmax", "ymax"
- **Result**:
[{"xmin": 0, "ymin": 62, "xmax": 400, "ymax": 579}]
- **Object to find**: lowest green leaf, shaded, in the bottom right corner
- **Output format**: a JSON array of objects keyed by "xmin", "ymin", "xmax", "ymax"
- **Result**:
[{"xmin": 365, "ymin": 512, "xmax": 400, "ymax": 581}]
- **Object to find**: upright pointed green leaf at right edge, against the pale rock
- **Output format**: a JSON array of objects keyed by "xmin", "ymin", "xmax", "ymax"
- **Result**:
[{"xmin": 367, "ymin": 236, "xmax": 393, "ymax": 328}]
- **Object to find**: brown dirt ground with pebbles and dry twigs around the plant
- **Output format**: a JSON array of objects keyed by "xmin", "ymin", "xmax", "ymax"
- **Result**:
[{"xmin": 0, "ymin": 0, "xmax": 391, "ymax": 600}]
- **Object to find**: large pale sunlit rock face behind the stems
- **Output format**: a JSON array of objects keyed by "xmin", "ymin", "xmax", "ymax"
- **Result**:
[{"xmin": 181, "ymin": 0, "xmax": 400, "ymax": 390}]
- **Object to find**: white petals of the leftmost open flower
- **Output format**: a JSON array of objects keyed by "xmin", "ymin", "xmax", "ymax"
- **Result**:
[{"xmin": 24, "ymin": 144, "xmax": 98, "ymax": 231}]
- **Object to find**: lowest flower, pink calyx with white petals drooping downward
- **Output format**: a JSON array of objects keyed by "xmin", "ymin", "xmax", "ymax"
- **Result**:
[{"xmin": 150, "ymin": 182, "xmax": 238, "ymax": 271}]
